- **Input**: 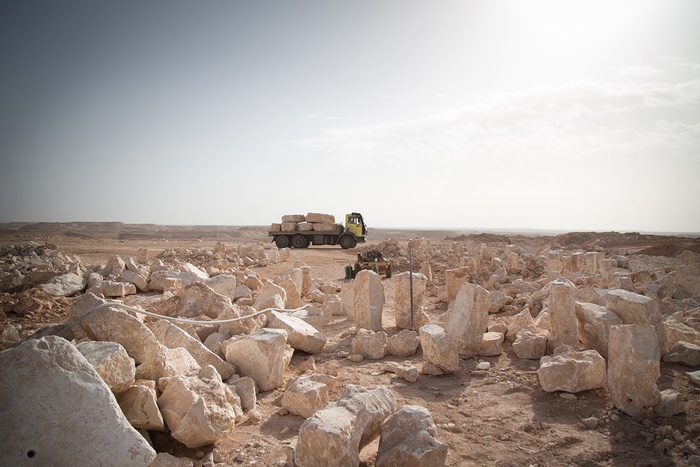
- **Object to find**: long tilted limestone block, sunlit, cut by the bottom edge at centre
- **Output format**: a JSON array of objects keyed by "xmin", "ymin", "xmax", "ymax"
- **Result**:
[{"xmin": 294, "ymin": 384, "xmax": 397, "ymax": 467}]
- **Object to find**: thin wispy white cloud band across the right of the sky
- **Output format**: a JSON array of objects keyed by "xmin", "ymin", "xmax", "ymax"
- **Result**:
[{"xmin": 297, "ymin": 67, "xmax": 700, "ymax": 170}]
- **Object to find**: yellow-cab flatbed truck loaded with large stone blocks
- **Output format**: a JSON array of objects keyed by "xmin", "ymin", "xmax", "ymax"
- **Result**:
[{"xmin": 269, "ymin": 212, "xmax": 367, "ymax": 250}]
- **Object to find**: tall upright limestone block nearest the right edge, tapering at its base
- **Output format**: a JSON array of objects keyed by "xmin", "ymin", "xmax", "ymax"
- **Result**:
[{"xmin": 608, "ymin": 324, "xmax": 661, "ymax": 417}]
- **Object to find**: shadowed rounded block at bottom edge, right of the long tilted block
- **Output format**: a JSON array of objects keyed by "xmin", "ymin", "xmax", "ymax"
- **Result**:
[{"xmin": 375, "ymin": 405, "xmax": 448, "ymax": 467}]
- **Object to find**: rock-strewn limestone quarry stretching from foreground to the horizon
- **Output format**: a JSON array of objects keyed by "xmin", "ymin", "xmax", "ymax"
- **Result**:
[{"xmin": 0, "ymin": 223, "xmax": 700, "ymax": 466}]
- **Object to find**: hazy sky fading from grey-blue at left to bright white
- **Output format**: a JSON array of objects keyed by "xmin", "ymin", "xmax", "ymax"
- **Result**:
[{"xmin": 0, "ymin": 0, "xmax": 700, "ymax": 232}]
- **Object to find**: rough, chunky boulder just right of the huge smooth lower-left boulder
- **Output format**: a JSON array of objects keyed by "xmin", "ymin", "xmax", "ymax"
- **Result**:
[{"xmin": 158, "ymin": 375, "xmax": 235, "ymax": 449}]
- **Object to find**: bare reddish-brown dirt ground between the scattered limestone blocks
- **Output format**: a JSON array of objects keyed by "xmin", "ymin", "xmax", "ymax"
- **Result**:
[{"xmin": 0, "ymin": 225, "xmax": 700, "ymax": 466}]
